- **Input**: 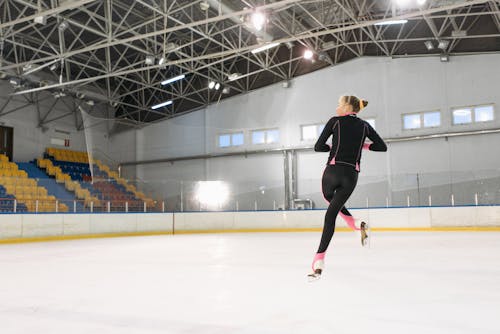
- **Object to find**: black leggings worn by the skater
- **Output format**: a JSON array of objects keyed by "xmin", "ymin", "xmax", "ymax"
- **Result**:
[{"xmin": 318, "ymin": 164, "xmax": 358, "ymax": 253}]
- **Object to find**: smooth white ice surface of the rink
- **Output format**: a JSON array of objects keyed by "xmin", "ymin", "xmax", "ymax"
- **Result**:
[{"xmin": 0, "ymin": 232, "xmax": 500, "ymax": 334}]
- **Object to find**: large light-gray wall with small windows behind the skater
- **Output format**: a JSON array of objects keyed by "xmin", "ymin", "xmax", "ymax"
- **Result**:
[{"xmin": 123, "ymin": 54, "xmax": 500, "ymax": 208}]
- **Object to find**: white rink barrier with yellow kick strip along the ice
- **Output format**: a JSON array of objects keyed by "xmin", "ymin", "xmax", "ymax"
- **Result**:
[{"xmin": 0, "ymin": 206, "xmax": 500, "ymax": 243}]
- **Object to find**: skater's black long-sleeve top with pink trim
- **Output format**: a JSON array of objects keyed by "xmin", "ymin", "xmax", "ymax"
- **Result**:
[{"xmin": 314, "ymin": 115, "xmax": 387, "ymax": 171}]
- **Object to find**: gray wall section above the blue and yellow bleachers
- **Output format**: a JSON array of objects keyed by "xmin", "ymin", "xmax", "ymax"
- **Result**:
[{"xmin": 0, "ymin": 81, "xmax": 136, "ymax": 167}]
